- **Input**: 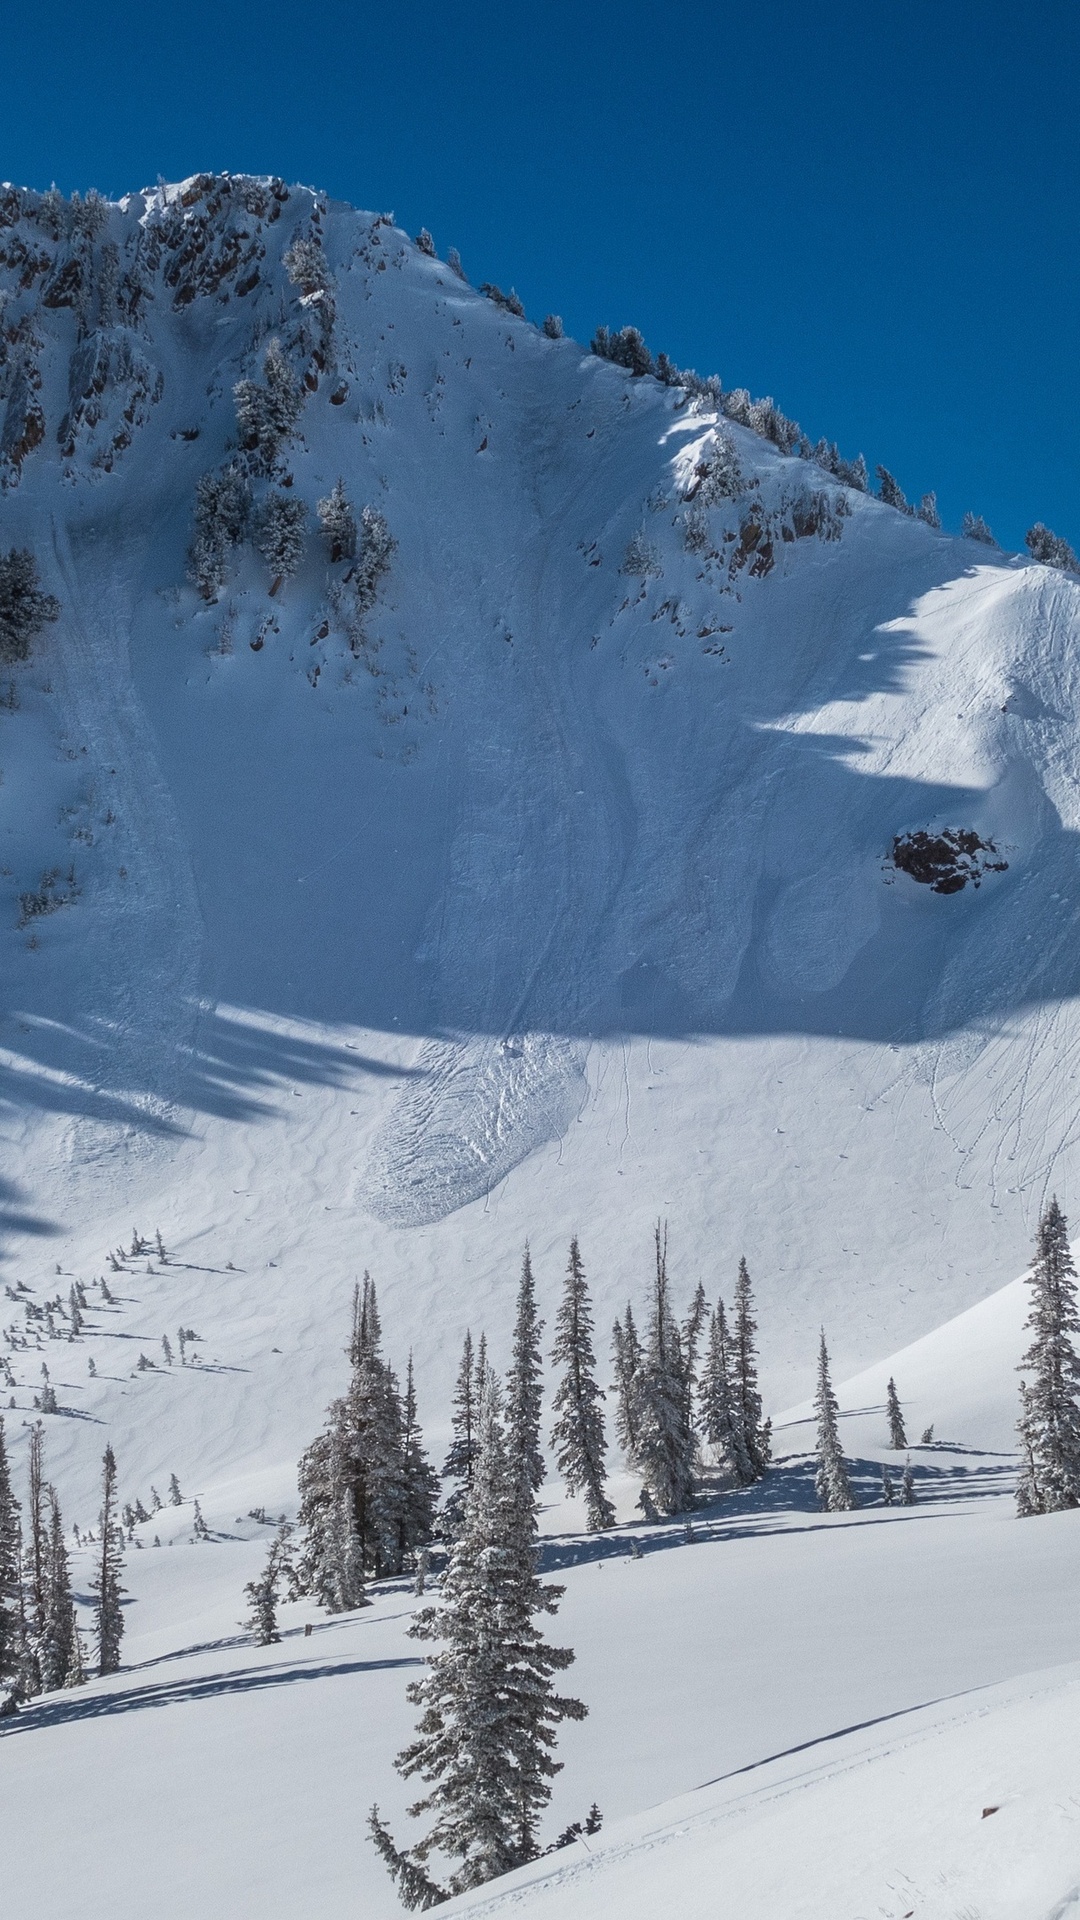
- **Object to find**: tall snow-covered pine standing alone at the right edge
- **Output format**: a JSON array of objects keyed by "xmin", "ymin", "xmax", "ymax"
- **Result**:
[{"xmin": 1017, "ymin": 1198, "xmax": 1080, "ymax": 1515}]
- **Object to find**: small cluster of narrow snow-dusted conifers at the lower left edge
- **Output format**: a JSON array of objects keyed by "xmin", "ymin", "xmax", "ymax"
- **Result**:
[{"xmin": 0, "ymin": 1419, "xmax": 123, "ymax": 1715}]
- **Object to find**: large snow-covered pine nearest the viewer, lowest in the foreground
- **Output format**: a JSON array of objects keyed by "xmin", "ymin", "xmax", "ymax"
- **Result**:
[{"xmin": 373, "ymin": 1379, "xmax": 586, "ymax": 1905}]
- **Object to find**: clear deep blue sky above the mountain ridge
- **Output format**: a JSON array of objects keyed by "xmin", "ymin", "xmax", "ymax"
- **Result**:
[{"xmin": 0, "ymin": 0, "xmax": 1080, "ymax": 547}]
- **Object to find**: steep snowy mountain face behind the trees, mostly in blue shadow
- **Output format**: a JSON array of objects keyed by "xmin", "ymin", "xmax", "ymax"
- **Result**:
[{"xmin": 0, "ymin": 177, "xmax": 1080, "ymax": 1512}]
